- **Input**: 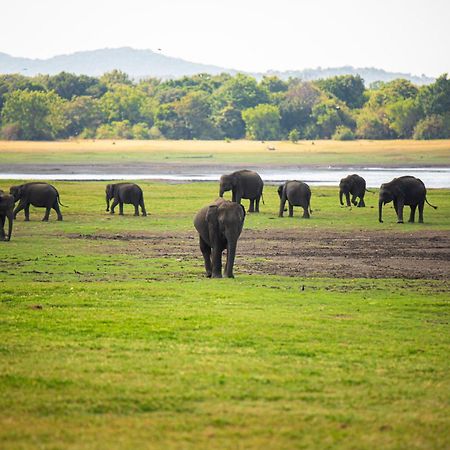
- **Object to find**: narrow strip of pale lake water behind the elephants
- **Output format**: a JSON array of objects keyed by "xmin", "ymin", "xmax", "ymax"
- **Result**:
[{"xmin": 0, "ymin": 167, "xmax": 450, "ymax": 188}]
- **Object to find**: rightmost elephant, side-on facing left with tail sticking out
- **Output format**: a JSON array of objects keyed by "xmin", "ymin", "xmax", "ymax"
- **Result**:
[{"xmin": 378, "ymin": 175, "xmax": 437, "ymax": 223}]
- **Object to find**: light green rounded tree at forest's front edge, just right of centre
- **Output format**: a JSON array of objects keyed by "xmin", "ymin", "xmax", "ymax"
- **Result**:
[{"xmin": 242, "ymin": 104, "xmax": 281, "ymax": 140}]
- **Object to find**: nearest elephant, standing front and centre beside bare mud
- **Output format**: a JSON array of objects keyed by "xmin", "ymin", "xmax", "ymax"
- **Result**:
[{"xmin": 194, "ymin": 198, "xmax": 245, "ymax": 278}]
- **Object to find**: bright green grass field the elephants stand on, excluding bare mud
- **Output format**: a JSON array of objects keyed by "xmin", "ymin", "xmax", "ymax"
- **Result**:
[{"xmin": 0, "ymin": 181, "xmax": 450, "ymax": 449}]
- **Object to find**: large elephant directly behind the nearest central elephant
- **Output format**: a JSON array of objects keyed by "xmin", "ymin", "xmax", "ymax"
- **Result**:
[{"xmin": 219, "ymin": 170, "xmax": 264, "ymax": 212}]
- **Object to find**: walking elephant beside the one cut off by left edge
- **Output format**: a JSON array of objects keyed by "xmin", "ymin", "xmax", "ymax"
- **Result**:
[{"xmin": 9, "ymin": 182, "xmax": 64, "ymax": 222}]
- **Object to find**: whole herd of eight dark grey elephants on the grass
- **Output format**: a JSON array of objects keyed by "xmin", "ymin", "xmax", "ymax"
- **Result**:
[{"xmin": 0, "ymin": 170, "xmax": 437, "ymax": 278}]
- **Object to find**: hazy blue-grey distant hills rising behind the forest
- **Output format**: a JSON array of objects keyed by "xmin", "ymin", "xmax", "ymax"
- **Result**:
[{"xmin": 0, "ymin": 47, "xmax": 434, "ymax": 85}]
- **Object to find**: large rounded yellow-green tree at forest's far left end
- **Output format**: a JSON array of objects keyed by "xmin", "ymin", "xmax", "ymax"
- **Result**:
[{"xmin": 2, "ymin": 90, "xmax": 67, "ymax": 140}]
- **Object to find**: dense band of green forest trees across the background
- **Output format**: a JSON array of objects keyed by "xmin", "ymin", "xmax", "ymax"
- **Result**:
[{"xmin": 0, "ymin": 71, "xmax": 450, "ymax": 142}]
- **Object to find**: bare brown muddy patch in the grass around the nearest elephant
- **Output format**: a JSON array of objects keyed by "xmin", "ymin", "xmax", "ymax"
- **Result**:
[{"xmin": 71, "ymin": 229, "xmax": 450, "ymax": 280}]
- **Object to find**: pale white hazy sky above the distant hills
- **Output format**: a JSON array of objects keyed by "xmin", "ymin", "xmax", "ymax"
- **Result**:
[{"xmin": 0, "ymin": 0, "xmax": 450, "ymax": 76}]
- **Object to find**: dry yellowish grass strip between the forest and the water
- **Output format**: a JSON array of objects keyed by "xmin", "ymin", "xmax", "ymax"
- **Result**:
[{"xmin": 0, "ymin": 140, "xmax": 450, "ymax": 166}]
